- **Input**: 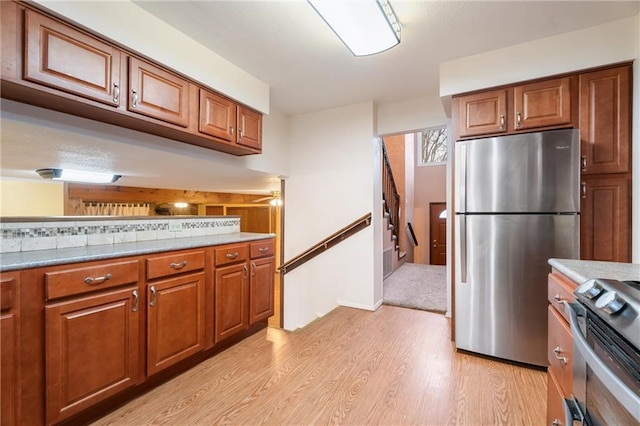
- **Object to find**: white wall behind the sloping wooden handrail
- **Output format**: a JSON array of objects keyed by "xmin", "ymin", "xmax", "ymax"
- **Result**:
[{"xmin": 284, "ymin": 102, "xmax": 382, "ymax": 330}]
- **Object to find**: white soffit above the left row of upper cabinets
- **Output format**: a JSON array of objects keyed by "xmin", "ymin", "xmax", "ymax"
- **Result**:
[{"xmin": 35, "ymin": 0, "xmax": 269, "ymax": 113}]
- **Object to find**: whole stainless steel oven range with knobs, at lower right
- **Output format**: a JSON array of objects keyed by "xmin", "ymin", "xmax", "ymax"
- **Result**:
[{"xmin": 565, "ymin": 279, "xmax": 640, "ymax": 426}]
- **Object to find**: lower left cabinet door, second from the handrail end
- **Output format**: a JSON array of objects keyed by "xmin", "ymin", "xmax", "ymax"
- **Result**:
[{"xmin": 214, "ymin": 262, "xmax": 249, "ymax": 343}]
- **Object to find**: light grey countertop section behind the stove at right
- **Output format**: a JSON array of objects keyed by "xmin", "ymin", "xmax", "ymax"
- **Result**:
[{"xmin": 549, "ymin": 259, "xmax": 640, "ymax": 284}]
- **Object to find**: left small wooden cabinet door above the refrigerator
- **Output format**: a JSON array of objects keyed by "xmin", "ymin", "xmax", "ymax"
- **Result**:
[{"xmin": 457, "ymin": 89, "xmax": 507, "ymax": 137}]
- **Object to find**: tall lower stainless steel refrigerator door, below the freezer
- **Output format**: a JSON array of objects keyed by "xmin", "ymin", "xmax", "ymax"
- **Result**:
[{"xmin": 455, "ymin": 215, "xmax": 580, "ymax": 366}]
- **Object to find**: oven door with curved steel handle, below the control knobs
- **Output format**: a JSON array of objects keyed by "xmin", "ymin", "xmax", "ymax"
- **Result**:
[{"xmin": 565, "ymin": 303, "xmax": 640, "ymax": 426}]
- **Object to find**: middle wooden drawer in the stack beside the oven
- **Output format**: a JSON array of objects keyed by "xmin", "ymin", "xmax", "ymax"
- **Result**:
[{"xmin": 547, "ymin": 306, "xmax": 573, "ymax": 395}]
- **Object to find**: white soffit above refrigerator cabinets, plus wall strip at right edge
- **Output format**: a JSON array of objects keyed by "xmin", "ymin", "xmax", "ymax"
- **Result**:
[{"xmin": 440, "ymin": 15, "xmax": 640, "ymax": 263}]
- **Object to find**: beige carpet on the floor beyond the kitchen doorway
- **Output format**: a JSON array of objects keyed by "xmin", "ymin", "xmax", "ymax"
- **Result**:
[{"xmin": 383, "ymin": 263, "xmax": 447, "ymax": 313}]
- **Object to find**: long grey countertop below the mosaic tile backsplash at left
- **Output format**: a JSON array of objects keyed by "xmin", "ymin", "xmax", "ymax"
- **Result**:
[{"xmin": 0, "ymin": 232, "xmax": 275, "ymax": 272}]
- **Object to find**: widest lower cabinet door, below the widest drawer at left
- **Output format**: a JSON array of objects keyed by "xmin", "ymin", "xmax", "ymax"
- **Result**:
[{"xmin": 45, "ymin": 288, "xmax": 139, "ymax": 424}]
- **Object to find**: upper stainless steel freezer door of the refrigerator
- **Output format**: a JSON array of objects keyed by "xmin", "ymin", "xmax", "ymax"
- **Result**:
[{"xmin": 455, "ymin": 129, "xmax": 580, "ymax": 213}]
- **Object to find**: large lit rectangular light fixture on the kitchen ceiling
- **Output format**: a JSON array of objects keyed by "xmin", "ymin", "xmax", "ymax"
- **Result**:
[{"xmin": 307, "ymin": 0, "xmax": 400, "ymax": 56}]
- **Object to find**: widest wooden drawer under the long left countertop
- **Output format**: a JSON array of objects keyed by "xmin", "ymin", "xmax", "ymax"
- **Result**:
[{"xmin": 44, "ymin": 260, "xmax": 138, "ymax": 300}]
